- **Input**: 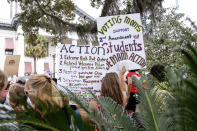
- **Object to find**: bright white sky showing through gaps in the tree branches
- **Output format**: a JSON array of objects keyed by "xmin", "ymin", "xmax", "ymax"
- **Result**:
[{"xmin": 0, "ymin": 0, "xmax": 197, "ymax": 23}]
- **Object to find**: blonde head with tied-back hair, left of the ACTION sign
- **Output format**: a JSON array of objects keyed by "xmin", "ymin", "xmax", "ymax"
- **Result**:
[{"xmin": 25, "ymin": 75, "xmax": 63, "ymax": 107}]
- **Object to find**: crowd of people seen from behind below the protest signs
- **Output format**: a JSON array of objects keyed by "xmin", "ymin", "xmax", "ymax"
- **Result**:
[{"xmin": 0, "ymin": 64, "xmax": 165, "ymax": 129}]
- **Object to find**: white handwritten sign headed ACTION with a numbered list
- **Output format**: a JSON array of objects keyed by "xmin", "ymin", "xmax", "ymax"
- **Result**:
[{"xmin": 58, "ymin": 44, "xmax": 106, "ymax": 102}]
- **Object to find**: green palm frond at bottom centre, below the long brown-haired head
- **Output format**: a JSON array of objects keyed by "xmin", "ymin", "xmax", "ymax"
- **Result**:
[{"xmin": 66, "ymin": 86, "xmax": 137, "ymax": 131}]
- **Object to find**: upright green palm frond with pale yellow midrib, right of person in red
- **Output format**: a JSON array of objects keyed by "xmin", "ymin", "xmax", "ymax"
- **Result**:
[{"xmin": 135, "ymin": 74, "xmax": 175, "ymax": 131}]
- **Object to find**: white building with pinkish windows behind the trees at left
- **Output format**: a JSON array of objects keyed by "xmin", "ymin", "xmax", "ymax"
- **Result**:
[{"xmin": 0, "ymin": 0, "xmax": 95, "ymax": 77}]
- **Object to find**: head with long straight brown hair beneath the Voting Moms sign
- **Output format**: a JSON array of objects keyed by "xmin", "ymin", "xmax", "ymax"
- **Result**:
[{"xmin": 101, "ymin": 73, "xmax": 123, "ymax": 105}]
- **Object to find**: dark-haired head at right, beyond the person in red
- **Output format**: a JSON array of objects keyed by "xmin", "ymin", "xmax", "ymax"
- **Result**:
[{"xmin": 150, "ymin": 64, "xmax": 166, "ymax": 82}]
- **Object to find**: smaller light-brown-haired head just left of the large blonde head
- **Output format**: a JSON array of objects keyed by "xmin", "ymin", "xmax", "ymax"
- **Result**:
[{"xmin": 9, "ymin": 84, "xmax": 27, "ymax": 108}]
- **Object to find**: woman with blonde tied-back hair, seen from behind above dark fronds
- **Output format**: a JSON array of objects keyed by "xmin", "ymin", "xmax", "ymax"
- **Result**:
[{"xmin": 19, "ymin": 75, "xmax": 71, "ymax": 130}]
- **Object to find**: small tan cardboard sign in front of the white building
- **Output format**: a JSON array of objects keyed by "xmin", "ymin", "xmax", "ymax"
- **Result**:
[{"xmin": 4, "ymin": 55, "xmax": 20, "ymax": 76}]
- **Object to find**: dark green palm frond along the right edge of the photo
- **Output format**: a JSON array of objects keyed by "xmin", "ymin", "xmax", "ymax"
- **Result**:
[{"xmin": 171, "ymin": 45, "xmax": 197, "ymax": 130}]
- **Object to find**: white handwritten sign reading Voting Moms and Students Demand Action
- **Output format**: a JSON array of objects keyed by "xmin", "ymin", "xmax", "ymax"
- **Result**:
[{"xmin": 97, "ymin": 14, "xmax": 146, "ymax": 72}]
